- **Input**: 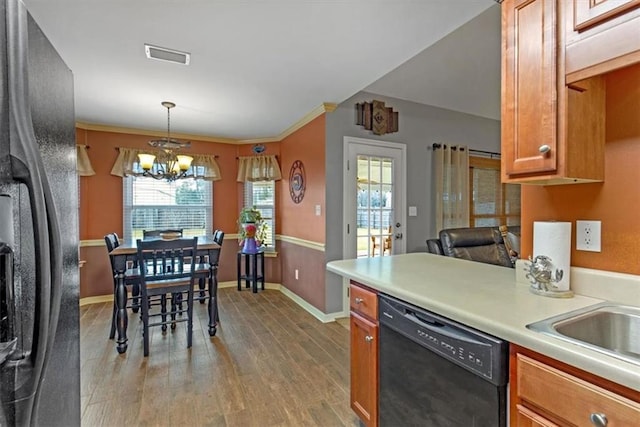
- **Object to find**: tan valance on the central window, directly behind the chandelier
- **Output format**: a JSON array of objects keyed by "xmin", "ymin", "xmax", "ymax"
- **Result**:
[{"xmin": 111, "ymin": 147, "xmax": 222, "ymax": 181}]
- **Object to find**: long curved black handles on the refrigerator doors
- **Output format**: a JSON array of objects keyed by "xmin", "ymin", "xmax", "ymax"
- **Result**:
[{"xmin": 6, "ymin": 1, "xmax": 62, "ymax": 424}]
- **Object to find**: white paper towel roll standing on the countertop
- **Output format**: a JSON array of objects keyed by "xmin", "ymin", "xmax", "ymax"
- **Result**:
[{"xmin": 533, "ymin": 221, "xmax": 571, "ymax": 291}]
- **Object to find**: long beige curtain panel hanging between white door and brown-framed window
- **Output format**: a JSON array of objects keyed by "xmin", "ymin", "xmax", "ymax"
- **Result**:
[{"xmin": 433, "ymin": 145, "xmax": 469, "ymax": 233}]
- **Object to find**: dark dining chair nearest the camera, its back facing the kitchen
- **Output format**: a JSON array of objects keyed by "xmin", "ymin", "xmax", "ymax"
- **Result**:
[{"xmin": 137, "ymin": 237, "xmax": 209, "ymax": 357}]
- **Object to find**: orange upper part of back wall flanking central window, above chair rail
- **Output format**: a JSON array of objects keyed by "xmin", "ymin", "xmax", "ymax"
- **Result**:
[{"xmin": 76, "ymin": 129, "xmax": 238, "ymax": 240}]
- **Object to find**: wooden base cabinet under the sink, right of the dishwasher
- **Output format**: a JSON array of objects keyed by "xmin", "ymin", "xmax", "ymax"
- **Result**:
[{"xmin": 510, "ymin": 345, "xmax": 640, "ymax": 427}]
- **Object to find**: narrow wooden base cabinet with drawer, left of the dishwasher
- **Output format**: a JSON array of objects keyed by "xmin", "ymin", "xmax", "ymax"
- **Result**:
[{"xmin": 349, "ymin": 282, "xmax": 379, "ymax": 427}]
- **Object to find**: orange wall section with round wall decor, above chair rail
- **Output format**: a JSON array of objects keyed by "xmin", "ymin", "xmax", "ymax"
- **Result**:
[{"xmin": 278, "ymin": 114, "xmax": 326, "ymax": 243}]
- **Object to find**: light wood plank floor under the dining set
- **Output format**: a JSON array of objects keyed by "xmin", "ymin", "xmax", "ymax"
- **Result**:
[{"xmin": 80, "ymin": 288, "xmax": 358, "ymax": 427}]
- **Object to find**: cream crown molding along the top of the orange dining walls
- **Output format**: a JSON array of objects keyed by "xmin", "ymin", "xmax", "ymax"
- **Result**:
[{"xmin": 76, "ymin": 102, "xmax": 338, "ymax": 145}]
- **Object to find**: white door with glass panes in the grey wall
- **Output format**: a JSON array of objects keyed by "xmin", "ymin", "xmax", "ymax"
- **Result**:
[{"xmin": 343, "ymin": 137, "xmax": 406, "ymax": 258}]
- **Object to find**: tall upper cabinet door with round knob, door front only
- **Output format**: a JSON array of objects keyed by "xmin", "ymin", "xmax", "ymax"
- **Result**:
[{"xmin": 502, "ymin": 0, "xmax": 557, "ymax": 181}]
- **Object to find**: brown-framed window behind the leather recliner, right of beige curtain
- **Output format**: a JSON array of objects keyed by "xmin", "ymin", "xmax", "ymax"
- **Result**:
[{"xmin": 469, "ymin": 157, "xmax": 520, "ymax": 227}]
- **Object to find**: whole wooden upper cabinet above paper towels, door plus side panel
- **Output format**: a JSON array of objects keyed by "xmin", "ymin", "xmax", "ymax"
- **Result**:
[{"xmin": 501, "ymin": 0, "xmax": 605, "ymax": 184}]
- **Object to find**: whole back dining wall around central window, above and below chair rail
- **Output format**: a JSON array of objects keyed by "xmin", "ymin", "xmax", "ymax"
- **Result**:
[{"xmin": 76, "ymin": 129, "xmax": 242, "ymax": 298}]
